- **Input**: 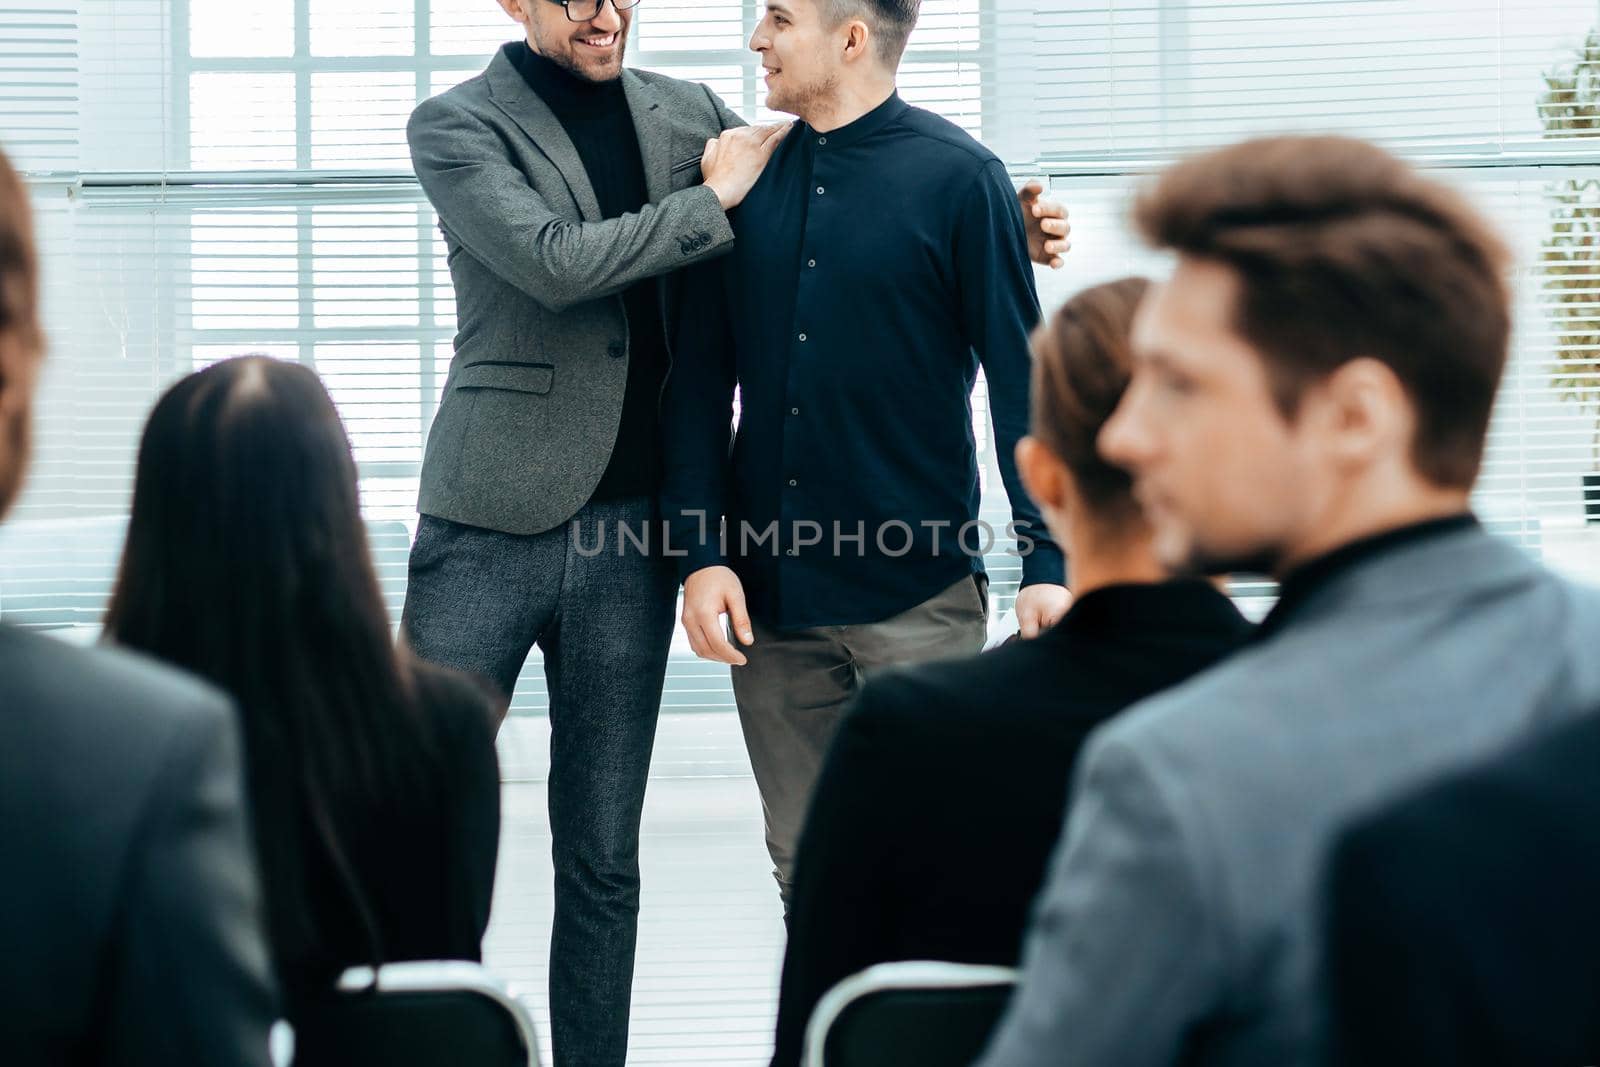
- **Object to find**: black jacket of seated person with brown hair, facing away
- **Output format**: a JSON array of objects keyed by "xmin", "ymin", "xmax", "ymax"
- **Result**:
[{"xmin": 773, "ymin": 581, "xmax": 1250, "ymax": 1065}]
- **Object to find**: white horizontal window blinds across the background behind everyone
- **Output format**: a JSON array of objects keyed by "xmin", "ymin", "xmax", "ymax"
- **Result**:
[{"xmin": 9, "ymin": 0, "xmax": 1600, "ymax": 713}]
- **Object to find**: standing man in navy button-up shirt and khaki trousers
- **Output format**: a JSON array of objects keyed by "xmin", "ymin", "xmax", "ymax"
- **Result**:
[{"xmin": 662, "ymin": 0, "xmax": 1069, "ymax": 902}]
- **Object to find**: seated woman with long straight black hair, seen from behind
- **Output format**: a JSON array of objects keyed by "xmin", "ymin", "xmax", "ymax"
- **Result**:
[{"xmin": 106, "ymin": 357, "xmax": 499, "ymax": 1021}]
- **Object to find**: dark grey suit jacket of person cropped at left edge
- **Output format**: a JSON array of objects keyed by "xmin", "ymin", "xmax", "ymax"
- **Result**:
[{"xmin": 0, "ymin": 627, "xmax": 277, "ymax": 1067}]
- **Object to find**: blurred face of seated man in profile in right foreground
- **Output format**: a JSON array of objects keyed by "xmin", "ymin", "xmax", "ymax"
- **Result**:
[{"xmin": 1099, "ymin": 259, "xmax": 1334, "ymax": 574}]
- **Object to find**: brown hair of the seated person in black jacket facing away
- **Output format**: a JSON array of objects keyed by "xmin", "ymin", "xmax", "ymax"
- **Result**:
[{"xmin": 1030, "ymin": 278, "xmax": 1150, "ymax": 526}]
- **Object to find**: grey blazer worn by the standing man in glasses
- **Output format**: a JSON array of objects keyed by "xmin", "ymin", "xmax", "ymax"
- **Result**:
[{"xmin": 406, "ymin": 51, "xmax": 739, "ymax": 534}]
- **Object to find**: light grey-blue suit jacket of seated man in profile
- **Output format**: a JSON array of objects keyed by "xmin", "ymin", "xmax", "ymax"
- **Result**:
[{"xmin": 979, "ymin": 530, "xmax": 1600, "ymax": 1067}]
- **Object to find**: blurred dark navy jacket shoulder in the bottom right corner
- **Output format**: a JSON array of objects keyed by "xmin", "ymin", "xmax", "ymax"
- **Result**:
[{"xmin": 1328, "ymin": 703, "xmax": 1600, "ymax": 1067}]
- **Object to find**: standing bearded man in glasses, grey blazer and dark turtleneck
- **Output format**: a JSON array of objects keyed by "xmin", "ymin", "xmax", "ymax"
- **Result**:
[{"xmin": 403, "ymin": 0, "xmax": 1066, "ymax": 1067}]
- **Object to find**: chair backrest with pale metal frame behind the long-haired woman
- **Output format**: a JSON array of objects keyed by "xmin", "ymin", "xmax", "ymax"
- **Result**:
[{"xmin": 293, "ymin": 960, "xmax": 539, "ymax": 1067}]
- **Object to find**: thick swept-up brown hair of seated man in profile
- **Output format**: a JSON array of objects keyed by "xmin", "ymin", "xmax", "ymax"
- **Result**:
[{"xmin": 1134, "ymin": 136, "xmax": 1510, "ymax": 488}]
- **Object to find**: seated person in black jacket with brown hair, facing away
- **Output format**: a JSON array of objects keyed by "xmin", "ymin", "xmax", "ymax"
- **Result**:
[{"xmin": 773, "ymin": 278, "xmax": 1250, "ymax": 1067}]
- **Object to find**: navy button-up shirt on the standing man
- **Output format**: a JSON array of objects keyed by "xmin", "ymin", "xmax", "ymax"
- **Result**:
[{"xmin": 662, "ymin": 96, "xmax": 1064, "ymax": 629}]
